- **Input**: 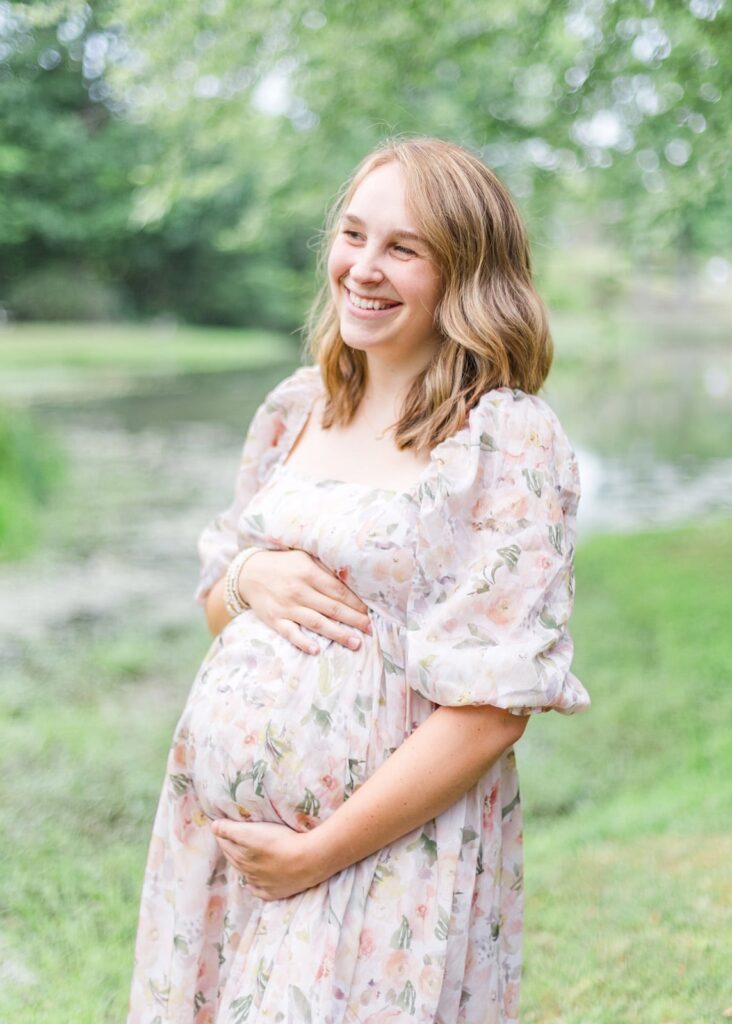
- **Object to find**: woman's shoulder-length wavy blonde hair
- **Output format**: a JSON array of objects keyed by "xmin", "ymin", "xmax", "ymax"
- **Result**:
[{"xmin": 305, "ymin": 137, "xmax": 553, "ymax": 452}]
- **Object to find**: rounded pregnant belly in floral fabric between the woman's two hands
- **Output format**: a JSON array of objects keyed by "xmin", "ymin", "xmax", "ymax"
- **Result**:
[{"xmin": 177, "ymin": 612, "xmax": 382, "ymax": 830}]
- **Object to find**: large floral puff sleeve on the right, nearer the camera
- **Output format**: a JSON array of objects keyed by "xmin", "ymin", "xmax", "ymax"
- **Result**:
[{"xmin": 405, "ymin": 388, "xmax": 590, "ymax": 715}]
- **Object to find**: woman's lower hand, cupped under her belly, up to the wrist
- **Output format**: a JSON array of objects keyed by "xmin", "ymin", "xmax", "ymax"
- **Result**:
[{"xmin": 211, "ymin": 818, "xmax": 322, "ymax": 900}]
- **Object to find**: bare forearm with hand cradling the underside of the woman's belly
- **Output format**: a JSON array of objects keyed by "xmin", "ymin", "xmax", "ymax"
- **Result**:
[{"xmin": 212, "ymin": 705, "xmax": 527, "ymax": 899}]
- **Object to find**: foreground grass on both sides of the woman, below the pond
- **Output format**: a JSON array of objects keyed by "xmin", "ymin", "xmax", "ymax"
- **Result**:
[{"xmin": 0, "ymin": 522, "xmax": 732, "ymax": 1024}]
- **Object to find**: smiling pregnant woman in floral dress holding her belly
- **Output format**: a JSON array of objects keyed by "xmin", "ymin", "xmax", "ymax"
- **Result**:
[{"xmin": 129, "ymin": 138, "xmax": 589, "ymax": 1024}]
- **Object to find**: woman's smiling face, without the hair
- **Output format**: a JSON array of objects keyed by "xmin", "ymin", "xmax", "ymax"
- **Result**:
[{"xmin": 328, "ymin": 162, "xmax": 441, "ymax": 361}]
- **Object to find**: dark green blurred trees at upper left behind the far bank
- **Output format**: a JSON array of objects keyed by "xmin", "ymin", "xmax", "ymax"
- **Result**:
[{"xmin": 0, "ymin": 0, "xmax": 304, "ymax": 328}]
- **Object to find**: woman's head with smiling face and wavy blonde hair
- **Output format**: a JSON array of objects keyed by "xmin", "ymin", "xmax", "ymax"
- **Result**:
[{"xmin": 308, "ymin": 139, "xmax": 553, "ymax": 460}]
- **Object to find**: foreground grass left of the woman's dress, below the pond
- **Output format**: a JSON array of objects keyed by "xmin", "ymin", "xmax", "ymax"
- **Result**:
[{"xmin": 0, "ymin": 622, "xmax": 208, "ymax": 1024}]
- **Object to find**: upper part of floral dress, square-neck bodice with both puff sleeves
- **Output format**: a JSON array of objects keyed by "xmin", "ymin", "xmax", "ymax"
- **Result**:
[{"xmin": 197, "ymin": 367, "xmax": 589, "ymax": 716}]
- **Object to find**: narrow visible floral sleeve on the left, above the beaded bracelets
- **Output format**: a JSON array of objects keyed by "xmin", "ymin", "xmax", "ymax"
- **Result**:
[{"xmin": 193, "ymin": 367, "xmax": 319, "ymax": 605}]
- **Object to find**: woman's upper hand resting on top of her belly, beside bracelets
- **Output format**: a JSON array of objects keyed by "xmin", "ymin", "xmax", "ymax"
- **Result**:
[{"xmin": 239, "ymin": 549, "xmax": 372, "ymax": 654}]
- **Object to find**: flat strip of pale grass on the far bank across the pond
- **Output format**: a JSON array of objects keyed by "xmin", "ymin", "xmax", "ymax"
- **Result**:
[{"xmin": 0, "ymin": 324, "xmax": 298, "ymax": 397}]
